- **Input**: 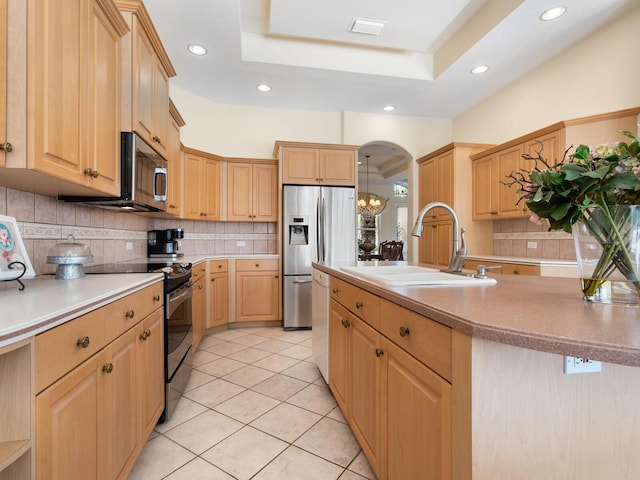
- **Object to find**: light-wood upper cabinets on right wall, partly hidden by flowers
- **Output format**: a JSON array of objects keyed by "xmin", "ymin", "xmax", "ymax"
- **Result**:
[{"xmin": 471, "ymin": 108, "xmax": 640, "ymax": 220}]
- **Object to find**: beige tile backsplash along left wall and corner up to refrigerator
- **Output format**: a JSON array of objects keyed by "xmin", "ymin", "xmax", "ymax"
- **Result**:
[{"xmin": 0, "ymin": 186, "xmax": 277, "ymax": 275}]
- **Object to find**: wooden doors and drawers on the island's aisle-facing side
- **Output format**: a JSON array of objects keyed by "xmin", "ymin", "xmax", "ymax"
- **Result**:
[{"xmin": 329, "ymin": 278, "xmax": 452, "ymax": 480}]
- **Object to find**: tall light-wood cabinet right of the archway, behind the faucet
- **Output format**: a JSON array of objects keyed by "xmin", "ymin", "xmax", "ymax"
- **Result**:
[{"xmin": 417, "ymin": 143, "xmax": 491, "ymax": 267}]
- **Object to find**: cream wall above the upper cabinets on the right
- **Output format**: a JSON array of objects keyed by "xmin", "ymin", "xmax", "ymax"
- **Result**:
[{"xmin": 453, "ymin": 7, "xmax": 640, "ymax": 143}]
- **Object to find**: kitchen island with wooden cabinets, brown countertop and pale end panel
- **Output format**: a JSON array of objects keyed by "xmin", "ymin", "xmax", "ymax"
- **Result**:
[{"xmin": 314, "ymin": 262, "xmax": 640, "ymax": 480}]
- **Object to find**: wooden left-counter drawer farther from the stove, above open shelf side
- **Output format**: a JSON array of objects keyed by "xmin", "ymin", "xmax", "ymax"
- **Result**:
[{"xmin": 36, "ymin": 307, "xmax": 107, "ymax": 392}]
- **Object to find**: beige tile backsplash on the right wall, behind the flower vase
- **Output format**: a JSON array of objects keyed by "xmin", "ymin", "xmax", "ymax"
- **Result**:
[{"xmin": 493, "ymin": 218, "xmax": 576, "ymax": 260}]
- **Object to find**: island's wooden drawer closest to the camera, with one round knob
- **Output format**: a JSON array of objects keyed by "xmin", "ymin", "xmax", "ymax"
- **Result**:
[{"xmin": 380, "ymin": 300, "xmax": 451, "ymax": 382}]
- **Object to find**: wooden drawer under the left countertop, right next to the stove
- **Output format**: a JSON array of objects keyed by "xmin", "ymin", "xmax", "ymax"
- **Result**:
[{"xmin": 105, "ymin": 282, "xmax": 164, "ymax": 343}]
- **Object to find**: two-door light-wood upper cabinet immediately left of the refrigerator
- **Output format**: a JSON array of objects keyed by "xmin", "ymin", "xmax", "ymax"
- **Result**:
[{"xmin": 227, "ymin": 158, "xmax": 278, "ymax": 222}]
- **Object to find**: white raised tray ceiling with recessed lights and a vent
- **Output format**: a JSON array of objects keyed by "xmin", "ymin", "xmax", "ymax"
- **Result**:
[{"xmin": 144, "ymin": 0, "xmax": 638, "ymax": 117}]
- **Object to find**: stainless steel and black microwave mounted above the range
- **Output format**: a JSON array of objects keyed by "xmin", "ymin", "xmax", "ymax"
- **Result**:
[{"xmin": 58, "ymin": 132, "xmax": 168, "ymax": 212}]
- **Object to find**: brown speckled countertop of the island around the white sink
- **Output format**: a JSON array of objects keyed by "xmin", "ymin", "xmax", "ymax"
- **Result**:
[{"xmin": 314, "ymin": 262, "xmax": 640, "ymax": 367}]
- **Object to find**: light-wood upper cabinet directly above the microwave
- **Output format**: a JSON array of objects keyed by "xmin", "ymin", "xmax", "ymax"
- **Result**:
[{"xmin": 116, "ymin": 0, "xmax": 176, "ymax": 160}]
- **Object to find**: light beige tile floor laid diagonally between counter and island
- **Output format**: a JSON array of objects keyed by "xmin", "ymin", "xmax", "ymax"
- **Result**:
[{"xmin": 129, "ymin": 327, "xmax": 375, "ymax": 480}]
